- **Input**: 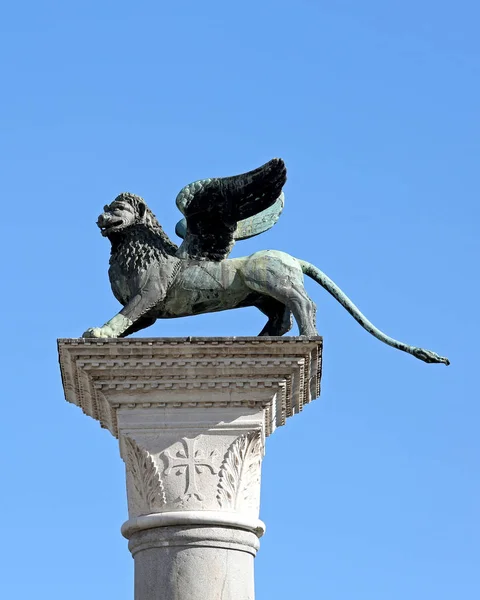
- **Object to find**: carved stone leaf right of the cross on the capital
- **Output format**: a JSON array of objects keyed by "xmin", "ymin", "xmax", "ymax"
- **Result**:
[{"xmin": 217, "ymin": 431, "xmax": 262, "ymax": 510}]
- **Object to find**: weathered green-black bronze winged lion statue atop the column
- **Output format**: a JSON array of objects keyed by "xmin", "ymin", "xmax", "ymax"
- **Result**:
[{"xmin": 83, "ymin": 158, "xmax": 449, "ymax": 365}]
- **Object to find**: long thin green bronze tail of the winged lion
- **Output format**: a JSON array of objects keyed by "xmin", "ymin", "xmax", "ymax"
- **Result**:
[{"xmin": 297, "ymin": 259, "xmax": 450, "ymax": 365}]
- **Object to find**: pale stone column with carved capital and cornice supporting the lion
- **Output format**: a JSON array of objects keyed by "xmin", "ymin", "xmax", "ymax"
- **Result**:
[{"xmin": 58, "ymin": 337, "xmax": 321, "ymax": 600}]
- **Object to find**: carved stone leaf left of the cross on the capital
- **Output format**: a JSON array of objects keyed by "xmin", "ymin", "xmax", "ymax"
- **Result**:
[{"xmin": 125, "ymin": 437, "xmax": 167, "ymax": 513}]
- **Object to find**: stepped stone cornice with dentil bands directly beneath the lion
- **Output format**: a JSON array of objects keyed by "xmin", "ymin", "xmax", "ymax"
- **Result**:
[{"xmin": 58, "ymin": 337, "xmax": 322, "ymax": 437}]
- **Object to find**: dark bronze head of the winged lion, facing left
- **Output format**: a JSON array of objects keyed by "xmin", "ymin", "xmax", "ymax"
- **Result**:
[{"xmin": 97, "ymin": 192, "xmax": 161, "ymax": 237}]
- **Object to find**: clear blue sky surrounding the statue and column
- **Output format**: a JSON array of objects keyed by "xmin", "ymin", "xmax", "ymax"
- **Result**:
[{"xmin": 0, "ymin": 0, "xmax": 480, "ymax": 600}]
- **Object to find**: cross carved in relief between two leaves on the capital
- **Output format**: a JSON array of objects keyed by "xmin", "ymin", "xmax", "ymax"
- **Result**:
[{"xmin": 163, "ymin": 438, "xmax": 218, "ymax": 502}]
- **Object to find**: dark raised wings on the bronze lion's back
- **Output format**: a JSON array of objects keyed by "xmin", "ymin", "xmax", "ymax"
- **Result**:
[{"xmin": 176, "ymin": 158, "xmax": 287, "ymax": 261}]
